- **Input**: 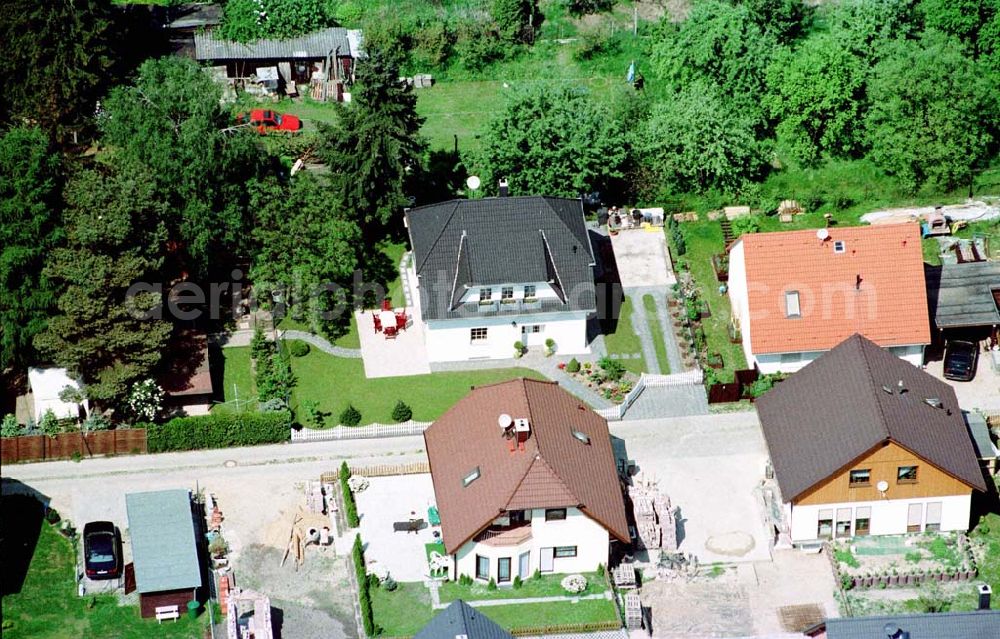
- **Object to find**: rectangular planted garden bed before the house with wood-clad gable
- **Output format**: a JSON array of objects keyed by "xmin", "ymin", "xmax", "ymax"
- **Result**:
[{"xmin": 829, "ymin": 533, "xmax": 977, "ymax": 590}]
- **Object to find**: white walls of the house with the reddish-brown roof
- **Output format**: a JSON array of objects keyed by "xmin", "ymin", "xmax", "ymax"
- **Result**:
[{"xmin": 454, "ymin": 508, "xmax": 610, "ymax": 580}]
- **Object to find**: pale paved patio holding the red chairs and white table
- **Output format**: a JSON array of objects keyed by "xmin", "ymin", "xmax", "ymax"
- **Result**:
[{"xmin": 354, "ymin": 307, "xmax": 431, "ymax": 379}]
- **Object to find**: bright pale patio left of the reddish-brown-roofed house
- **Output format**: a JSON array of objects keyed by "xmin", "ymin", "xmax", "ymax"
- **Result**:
[{"xmin": 355, "ymin": 474, "xmax": 439, "ymax": 582}]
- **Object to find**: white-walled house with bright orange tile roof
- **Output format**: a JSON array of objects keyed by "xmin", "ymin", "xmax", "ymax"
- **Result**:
[{"xmin": 728, "ymin": 224, "xmax": 931, "ymax": 373}]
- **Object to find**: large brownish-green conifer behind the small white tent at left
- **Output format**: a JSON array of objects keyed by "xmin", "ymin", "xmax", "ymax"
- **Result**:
[{"xmin": 35, "ymin": 168, "xmax": 171, "ymax": 406}]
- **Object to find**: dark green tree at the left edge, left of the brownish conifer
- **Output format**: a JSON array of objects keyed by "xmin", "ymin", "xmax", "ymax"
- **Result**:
[{"xmin": 0, "ymin": 127, "xmax": 62, "ymax": 370}]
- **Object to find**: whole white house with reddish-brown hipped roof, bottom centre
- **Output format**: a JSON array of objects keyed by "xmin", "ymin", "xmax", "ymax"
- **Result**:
[{"xmin": 424, "ymin": 379, "xmax": 629, "ymax": 584}]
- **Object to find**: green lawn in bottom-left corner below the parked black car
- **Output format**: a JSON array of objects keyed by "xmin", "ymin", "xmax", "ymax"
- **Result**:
[{"xmin": 3, "ymin": 512, "xmax": 208, "ymax": 639}]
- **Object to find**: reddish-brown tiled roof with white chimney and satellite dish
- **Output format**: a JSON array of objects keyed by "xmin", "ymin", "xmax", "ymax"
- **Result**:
[{"xmin": 424, "ymin": 379, "xmax": 629, "ymax": 553}]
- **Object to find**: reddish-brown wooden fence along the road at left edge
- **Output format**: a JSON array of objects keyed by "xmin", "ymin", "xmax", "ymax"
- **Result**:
[{"xmin": 0, "ymin": 428, "xmax": 146, "ymax": 464}]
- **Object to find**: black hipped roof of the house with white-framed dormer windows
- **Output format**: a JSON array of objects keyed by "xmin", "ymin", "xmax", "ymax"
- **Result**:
[{"xmin": 406, "ymin": 196, "xmax": 597, "ymax": 319}]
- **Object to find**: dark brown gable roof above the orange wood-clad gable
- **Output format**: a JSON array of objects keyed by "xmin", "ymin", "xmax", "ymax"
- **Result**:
[{"xmin": 757, "ymin": 334, "xmax": 986, "ymax": 501}]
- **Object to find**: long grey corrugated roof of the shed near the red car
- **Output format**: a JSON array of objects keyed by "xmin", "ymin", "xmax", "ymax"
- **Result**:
[{"xmin": 194, "ymin": 27, "xmax": 357, "ymax": 60}]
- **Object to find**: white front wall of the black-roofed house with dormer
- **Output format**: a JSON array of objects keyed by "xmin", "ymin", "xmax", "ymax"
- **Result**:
[{"xmin": 425, "ymin": 312, "xmax": 590, "ymax": 362}]
